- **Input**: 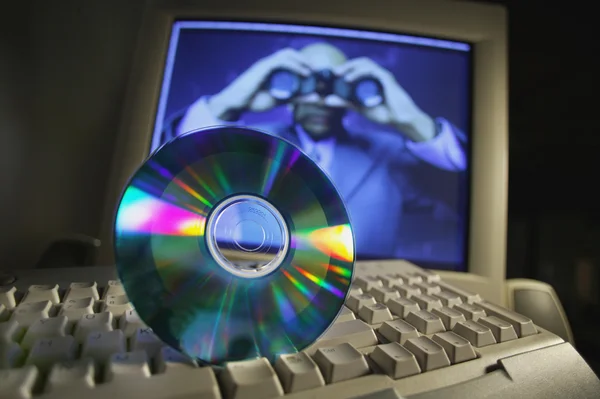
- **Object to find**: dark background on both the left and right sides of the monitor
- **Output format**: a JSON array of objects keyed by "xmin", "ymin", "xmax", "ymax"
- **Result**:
[{"xmin": 0, "ymin": 0, "xmax": 600, "ymax": 373}]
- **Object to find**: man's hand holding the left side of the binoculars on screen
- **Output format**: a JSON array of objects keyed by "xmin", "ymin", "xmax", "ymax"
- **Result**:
[{"xmin": 208, "ymin": 48, "xmax": 312, "ymax": 120}]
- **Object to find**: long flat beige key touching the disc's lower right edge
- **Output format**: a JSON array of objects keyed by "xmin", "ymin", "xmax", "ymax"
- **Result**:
[{"xmin": 305, "ymin": 320, "xmax": 377, "ymax": 355}]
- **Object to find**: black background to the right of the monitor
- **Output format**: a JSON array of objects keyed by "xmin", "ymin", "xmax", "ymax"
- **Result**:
[{"xmin": 486, "ymin": 0, "xmax": 600, "ymax": 374}]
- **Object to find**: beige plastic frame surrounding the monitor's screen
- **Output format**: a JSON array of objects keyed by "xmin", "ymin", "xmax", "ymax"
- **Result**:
[{"xmin": 100, "ymin": 0, "xmax": 508, "ymax": 302}]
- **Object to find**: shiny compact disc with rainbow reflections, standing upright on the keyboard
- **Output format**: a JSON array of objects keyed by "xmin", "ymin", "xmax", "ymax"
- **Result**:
[{"xmin": 114, "ymin": 127, "xmax": 355, "ymax": 365}]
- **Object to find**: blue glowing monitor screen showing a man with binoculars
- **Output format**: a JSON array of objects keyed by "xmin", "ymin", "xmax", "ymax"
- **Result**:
[{"xmin": 150, "ymin": 21, "xmax": 472, "ymax": 271}]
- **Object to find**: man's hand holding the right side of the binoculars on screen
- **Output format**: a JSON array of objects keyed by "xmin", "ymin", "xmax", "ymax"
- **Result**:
[{"xmin": 334, "ymin": 57, "xmax": 435, "ymax": 141}]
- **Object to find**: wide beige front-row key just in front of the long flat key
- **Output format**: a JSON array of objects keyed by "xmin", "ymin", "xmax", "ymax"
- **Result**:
[{"xmin": 313, "ymin": 342, "xmax": 369, "ymax": 384}]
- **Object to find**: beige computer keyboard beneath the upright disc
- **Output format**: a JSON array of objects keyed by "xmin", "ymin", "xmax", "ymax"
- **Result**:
[{"xmin": 0, "ymin": 262, "xmax": 600, "ymax": 399}]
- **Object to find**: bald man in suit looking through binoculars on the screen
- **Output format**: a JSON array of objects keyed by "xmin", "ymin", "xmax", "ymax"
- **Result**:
[{"xmin": 161, "ymin": 43, "xmax": 466, "ymax": 257}]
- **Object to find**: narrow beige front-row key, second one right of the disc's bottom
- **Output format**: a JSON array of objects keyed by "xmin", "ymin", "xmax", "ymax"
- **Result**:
[{"xmin": 275, "ymin": 352, "xmax": 325, "ymax": 393}]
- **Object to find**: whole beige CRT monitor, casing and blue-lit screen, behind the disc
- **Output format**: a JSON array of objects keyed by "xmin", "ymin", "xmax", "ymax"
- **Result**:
[{"xmin": 105, "ymin": 1, "xmax": 507, "ymax": 298}]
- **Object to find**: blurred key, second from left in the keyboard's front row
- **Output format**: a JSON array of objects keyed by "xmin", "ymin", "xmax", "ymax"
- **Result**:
[{"xmin": 44, "ymin": 358, "xmax": 96, "ymax": 397}]
